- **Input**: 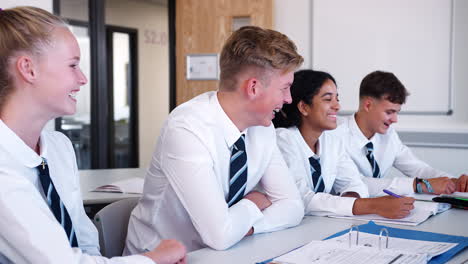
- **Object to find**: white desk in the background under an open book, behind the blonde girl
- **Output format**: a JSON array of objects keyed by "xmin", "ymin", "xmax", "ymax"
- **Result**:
[{"xmin": 80, "ymin": 168, "xmax": 146, "ymax": 205}]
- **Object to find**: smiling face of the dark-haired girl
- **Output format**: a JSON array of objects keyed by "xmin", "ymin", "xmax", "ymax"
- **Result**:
[{"xmin": 297, "ymin": 79, "xmax": 340, "ymax": 133}]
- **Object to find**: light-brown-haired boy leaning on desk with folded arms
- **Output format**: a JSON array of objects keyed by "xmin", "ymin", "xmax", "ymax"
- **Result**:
[{"xmin": 126, "ymin": 26, "xmax": 304, "ymax": 253}]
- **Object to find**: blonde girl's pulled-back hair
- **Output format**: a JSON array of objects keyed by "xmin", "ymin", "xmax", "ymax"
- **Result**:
[{"xmin": 0, "ymin": 6, "xmax": 67, "ymax": 110}]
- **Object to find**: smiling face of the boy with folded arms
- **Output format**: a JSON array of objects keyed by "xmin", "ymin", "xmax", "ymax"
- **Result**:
[{"xmin": 252, "ymin": 70, "xmax": 294, "ymax": 126}]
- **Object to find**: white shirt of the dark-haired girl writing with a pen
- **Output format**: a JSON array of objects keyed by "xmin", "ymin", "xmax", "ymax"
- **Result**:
[{"xmin": 276, "ymin": 126, "xmax": 369, "ymax": 215}]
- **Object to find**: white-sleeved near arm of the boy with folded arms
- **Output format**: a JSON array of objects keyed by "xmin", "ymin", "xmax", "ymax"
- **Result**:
[{"xmin": 161, "ymin": 126, "xmax": 263, "ymax": 250}]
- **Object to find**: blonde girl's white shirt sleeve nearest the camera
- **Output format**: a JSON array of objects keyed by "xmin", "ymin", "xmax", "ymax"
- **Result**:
[{"xmin": 0, "ymin": 173, "xmax": 153, "ymax": 264}]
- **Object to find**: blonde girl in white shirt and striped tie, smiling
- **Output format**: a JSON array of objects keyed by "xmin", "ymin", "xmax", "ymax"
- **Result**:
[{"xmin": 0, "ymin": 7, "xmax": 185, "ymax": 264}]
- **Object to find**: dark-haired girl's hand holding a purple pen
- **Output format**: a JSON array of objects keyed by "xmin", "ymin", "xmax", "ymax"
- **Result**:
[{"xmin": 373, "ymin": 195, "xmax": 414, "ymax": 219}]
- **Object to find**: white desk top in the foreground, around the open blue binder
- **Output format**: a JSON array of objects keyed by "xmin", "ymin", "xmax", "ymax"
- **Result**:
[{"xmin": 187, "ymin": 209, "xmax": 468, "ymax": 264}]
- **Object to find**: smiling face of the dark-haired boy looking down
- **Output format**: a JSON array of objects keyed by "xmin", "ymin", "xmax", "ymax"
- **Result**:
[{"xmin": 367, "ymin": 97, "xmax": 401, "ymax": 136}]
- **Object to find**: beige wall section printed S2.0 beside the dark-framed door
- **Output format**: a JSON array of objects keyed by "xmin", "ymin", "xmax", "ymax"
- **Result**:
[{"xmin": 106, "ymin": 0, "xmax": 169, "ymax": 168}]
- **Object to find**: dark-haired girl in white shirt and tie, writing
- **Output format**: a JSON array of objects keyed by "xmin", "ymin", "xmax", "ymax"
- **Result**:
[{"xmin": 273, "ymin": 70, "xmax": 414, "ymax": 218}]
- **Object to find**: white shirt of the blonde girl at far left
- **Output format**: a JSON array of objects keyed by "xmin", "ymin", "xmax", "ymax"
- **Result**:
[{"xmin": 0, "ymin": 120, "xmax": 153, "ymax": 264}]
